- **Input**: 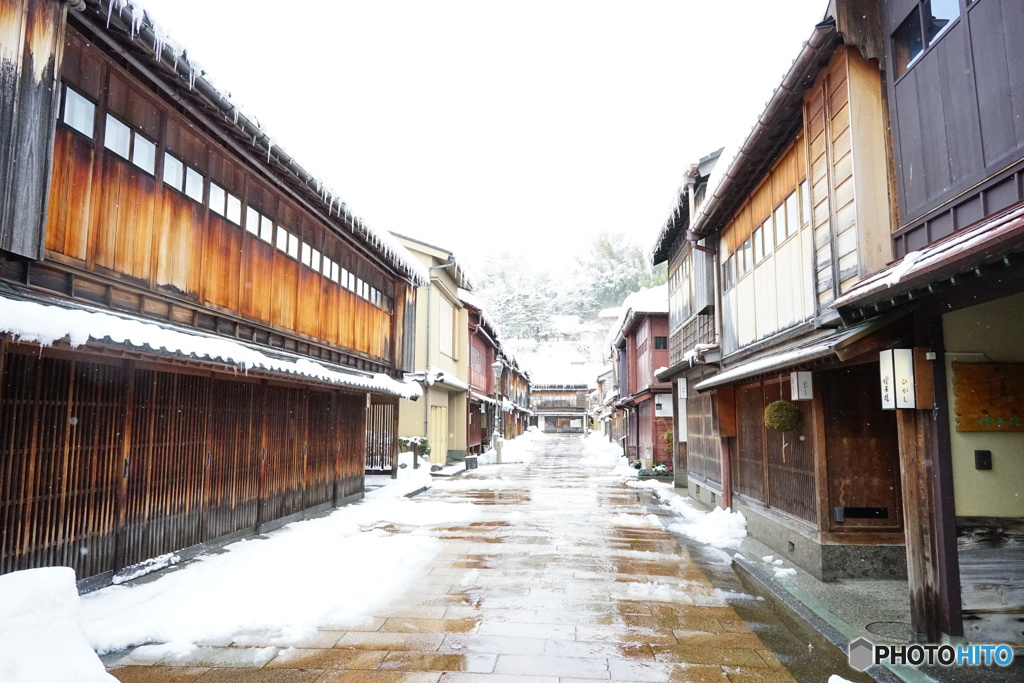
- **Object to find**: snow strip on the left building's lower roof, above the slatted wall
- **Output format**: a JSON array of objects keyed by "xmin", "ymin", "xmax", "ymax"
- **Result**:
[{"xmin": 0, "ymin": 297, "xmax": 422, "ymax": 398}]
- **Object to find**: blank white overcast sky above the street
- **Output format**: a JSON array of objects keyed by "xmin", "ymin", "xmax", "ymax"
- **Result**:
[{"xmin": 132, "ymin": 0, "xmax": 827, "ymax": 270}]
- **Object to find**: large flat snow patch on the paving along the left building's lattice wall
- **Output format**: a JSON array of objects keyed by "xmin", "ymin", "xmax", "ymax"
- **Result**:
[{"xmin": 76, "ymin": 468, "xmax": 484, "ymax": 657}]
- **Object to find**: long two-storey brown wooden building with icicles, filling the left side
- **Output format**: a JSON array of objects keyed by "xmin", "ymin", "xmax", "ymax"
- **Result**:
[{"xmin": 0, "ymin": 0, "xmax": 426, "ymax": 588}]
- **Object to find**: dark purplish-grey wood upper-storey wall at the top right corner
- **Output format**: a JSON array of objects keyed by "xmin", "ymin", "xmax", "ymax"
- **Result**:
[{"xmin": 882, "ymin": 0, "xmax": 1024, "ymax": 257}]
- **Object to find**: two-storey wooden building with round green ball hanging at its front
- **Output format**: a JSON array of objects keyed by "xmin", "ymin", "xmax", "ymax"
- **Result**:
[{"xmin": 655, "ymin": 2, "xmax": 905, "ymax": 581}]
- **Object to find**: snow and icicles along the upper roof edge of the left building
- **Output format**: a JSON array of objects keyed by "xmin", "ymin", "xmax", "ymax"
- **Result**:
[{"xmin": 82, "ymin": 0, "xmax": 430, "ymax": 286}]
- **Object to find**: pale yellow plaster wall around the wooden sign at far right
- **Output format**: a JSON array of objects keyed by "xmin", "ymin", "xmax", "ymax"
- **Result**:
[{"xmin": 942, "ymin": 293, "xmax": 1024, "ymax": 517}]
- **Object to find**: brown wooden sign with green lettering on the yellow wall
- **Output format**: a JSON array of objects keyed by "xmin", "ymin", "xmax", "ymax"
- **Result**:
[{"xmin": 953, "ymin": 362, "xmax": 1024, "ymax": 432}]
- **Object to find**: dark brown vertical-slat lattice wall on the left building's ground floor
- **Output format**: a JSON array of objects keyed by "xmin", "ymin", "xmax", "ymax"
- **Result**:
[{"xmin": 0, "ymin": 348, "xmax": 372, "ymax": 580}]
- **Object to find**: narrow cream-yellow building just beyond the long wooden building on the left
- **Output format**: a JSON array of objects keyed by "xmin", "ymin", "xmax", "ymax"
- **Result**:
[{"xmin": 395, "ymin": 234, "xmax": 471, "ymax": 466}]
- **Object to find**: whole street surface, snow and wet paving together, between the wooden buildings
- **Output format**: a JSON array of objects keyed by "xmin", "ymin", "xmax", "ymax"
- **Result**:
[{"xmin": 37, "ymin": 434, "xmax": 864, "ymax": 682}]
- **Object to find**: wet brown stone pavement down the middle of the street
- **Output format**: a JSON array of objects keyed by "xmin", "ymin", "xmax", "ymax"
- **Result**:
[{"xmin": 108, "ymin": 436, "xmax": 869, "ymax": 683}]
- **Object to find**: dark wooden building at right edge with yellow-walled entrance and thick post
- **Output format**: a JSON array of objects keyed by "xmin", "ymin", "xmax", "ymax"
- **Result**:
[{"xmin": 833, "ymin": 0, "xmax": 1024, "ymax": 645}]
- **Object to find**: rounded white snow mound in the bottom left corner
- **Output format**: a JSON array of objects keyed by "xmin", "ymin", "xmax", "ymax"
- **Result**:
[{"xmin": 0, "ymin": 567, "xmax": 116, "ymax": 683}]
